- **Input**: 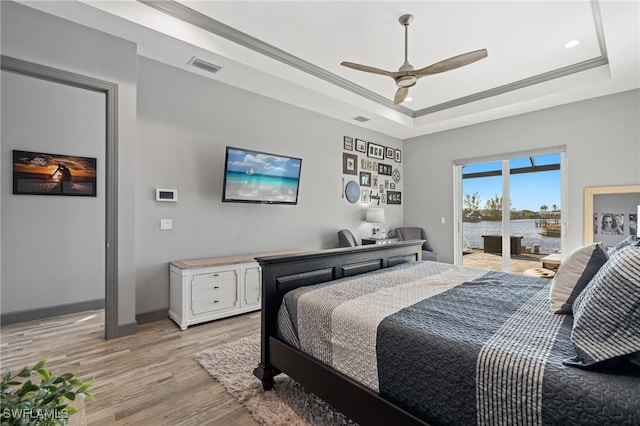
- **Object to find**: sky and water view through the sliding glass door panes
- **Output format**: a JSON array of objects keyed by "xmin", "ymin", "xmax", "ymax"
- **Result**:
[{"xmin": 462, "ymin": 154, "xmax": 561, "ymax": 269}]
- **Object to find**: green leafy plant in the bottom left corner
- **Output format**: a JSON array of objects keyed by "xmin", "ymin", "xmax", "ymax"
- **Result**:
[{"xmin": 0, "ymin": 359, "xmax": 93, "ymax": 426}]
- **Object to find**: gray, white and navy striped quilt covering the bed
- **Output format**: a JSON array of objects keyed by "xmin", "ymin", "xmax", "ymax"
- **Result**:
[{"xmin": 279, "ymin": 262, "xmax": 640, "ymax": 425}]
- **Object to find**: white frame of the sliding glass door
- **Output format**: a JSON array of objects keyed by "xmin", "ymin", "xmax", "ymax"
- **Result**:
[{"xmin": 453, "ymin": 145, "xmax": 569, "ymax": 272}]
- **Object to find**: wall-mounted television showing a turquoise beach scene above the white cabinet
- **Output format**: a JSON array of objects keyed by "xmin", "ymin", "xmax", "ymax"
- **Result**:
[{"xmin": 222, "ymin": 147, "xmax": 302, "ymax": 204}]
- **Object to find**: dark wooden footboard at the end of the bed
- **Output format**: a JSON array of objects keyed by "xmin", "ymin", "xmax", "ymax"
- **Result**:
[{"xmin": 256, "ymin": 240, "xmax": 424, "ymax": 363}]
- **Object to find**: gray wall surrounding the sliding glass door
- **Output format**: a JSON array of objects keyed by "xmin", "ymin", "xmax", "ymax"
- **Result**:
[{"xmin": 404, "ymin": 90, "xmax": 640, "ymax": 262}]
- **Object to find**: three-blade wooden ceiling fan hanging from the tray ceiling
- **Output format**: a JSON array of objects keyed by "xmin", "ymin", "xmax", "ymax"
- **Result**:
[{"xmin": 340, "ymin": 14, "xmax": 487, "ymax": 105}]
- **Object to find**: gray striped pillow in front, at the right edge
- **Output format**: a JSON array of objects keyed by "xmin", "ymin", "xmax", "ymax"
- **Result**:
[{"xmin": 564, "ymin": 245, "xmax": 640, "ymax": 367}]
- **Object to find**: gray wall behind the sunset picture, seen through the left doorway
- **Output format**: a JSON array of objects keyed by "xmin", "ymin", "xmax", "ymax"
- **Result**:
[{"xmin": 1, "ymin": 71, "xmax": 106, "ymax": 314}]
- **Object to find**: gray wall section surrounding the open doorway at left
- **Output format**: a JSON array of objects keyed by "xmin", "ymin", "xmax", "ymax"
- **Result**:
[{"xmin": 0, "ymin": 1, "xmax": 137, "ymax": 325}]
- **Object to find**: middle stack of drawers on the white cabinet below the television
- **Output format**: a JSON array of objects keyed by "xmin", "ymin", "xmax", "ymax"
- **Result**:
[{"xmin": 191, "ymin": 270, "xmax": 238, "ymax": 315}]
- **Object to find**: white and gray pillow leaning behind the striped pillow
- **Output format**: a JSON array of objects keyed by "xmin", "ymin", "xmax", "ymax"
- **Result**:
[{"xmin": 549, "ymin": 243, "xmax": 609, "ymax": 314}]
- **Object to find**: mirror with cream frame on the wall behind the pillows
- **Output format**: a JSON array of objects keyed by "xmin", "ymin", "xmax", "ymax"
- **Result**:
[{"xmin": 584, "ymin": 185, "xmax": 640, "ymax": 245}]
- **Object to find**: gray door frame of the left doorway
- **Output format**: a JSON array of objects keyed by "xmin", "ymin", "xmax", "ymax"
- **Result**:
[{"xmin": 0, "ymin": 55, "xmax": 121, "ymax": 340}]
